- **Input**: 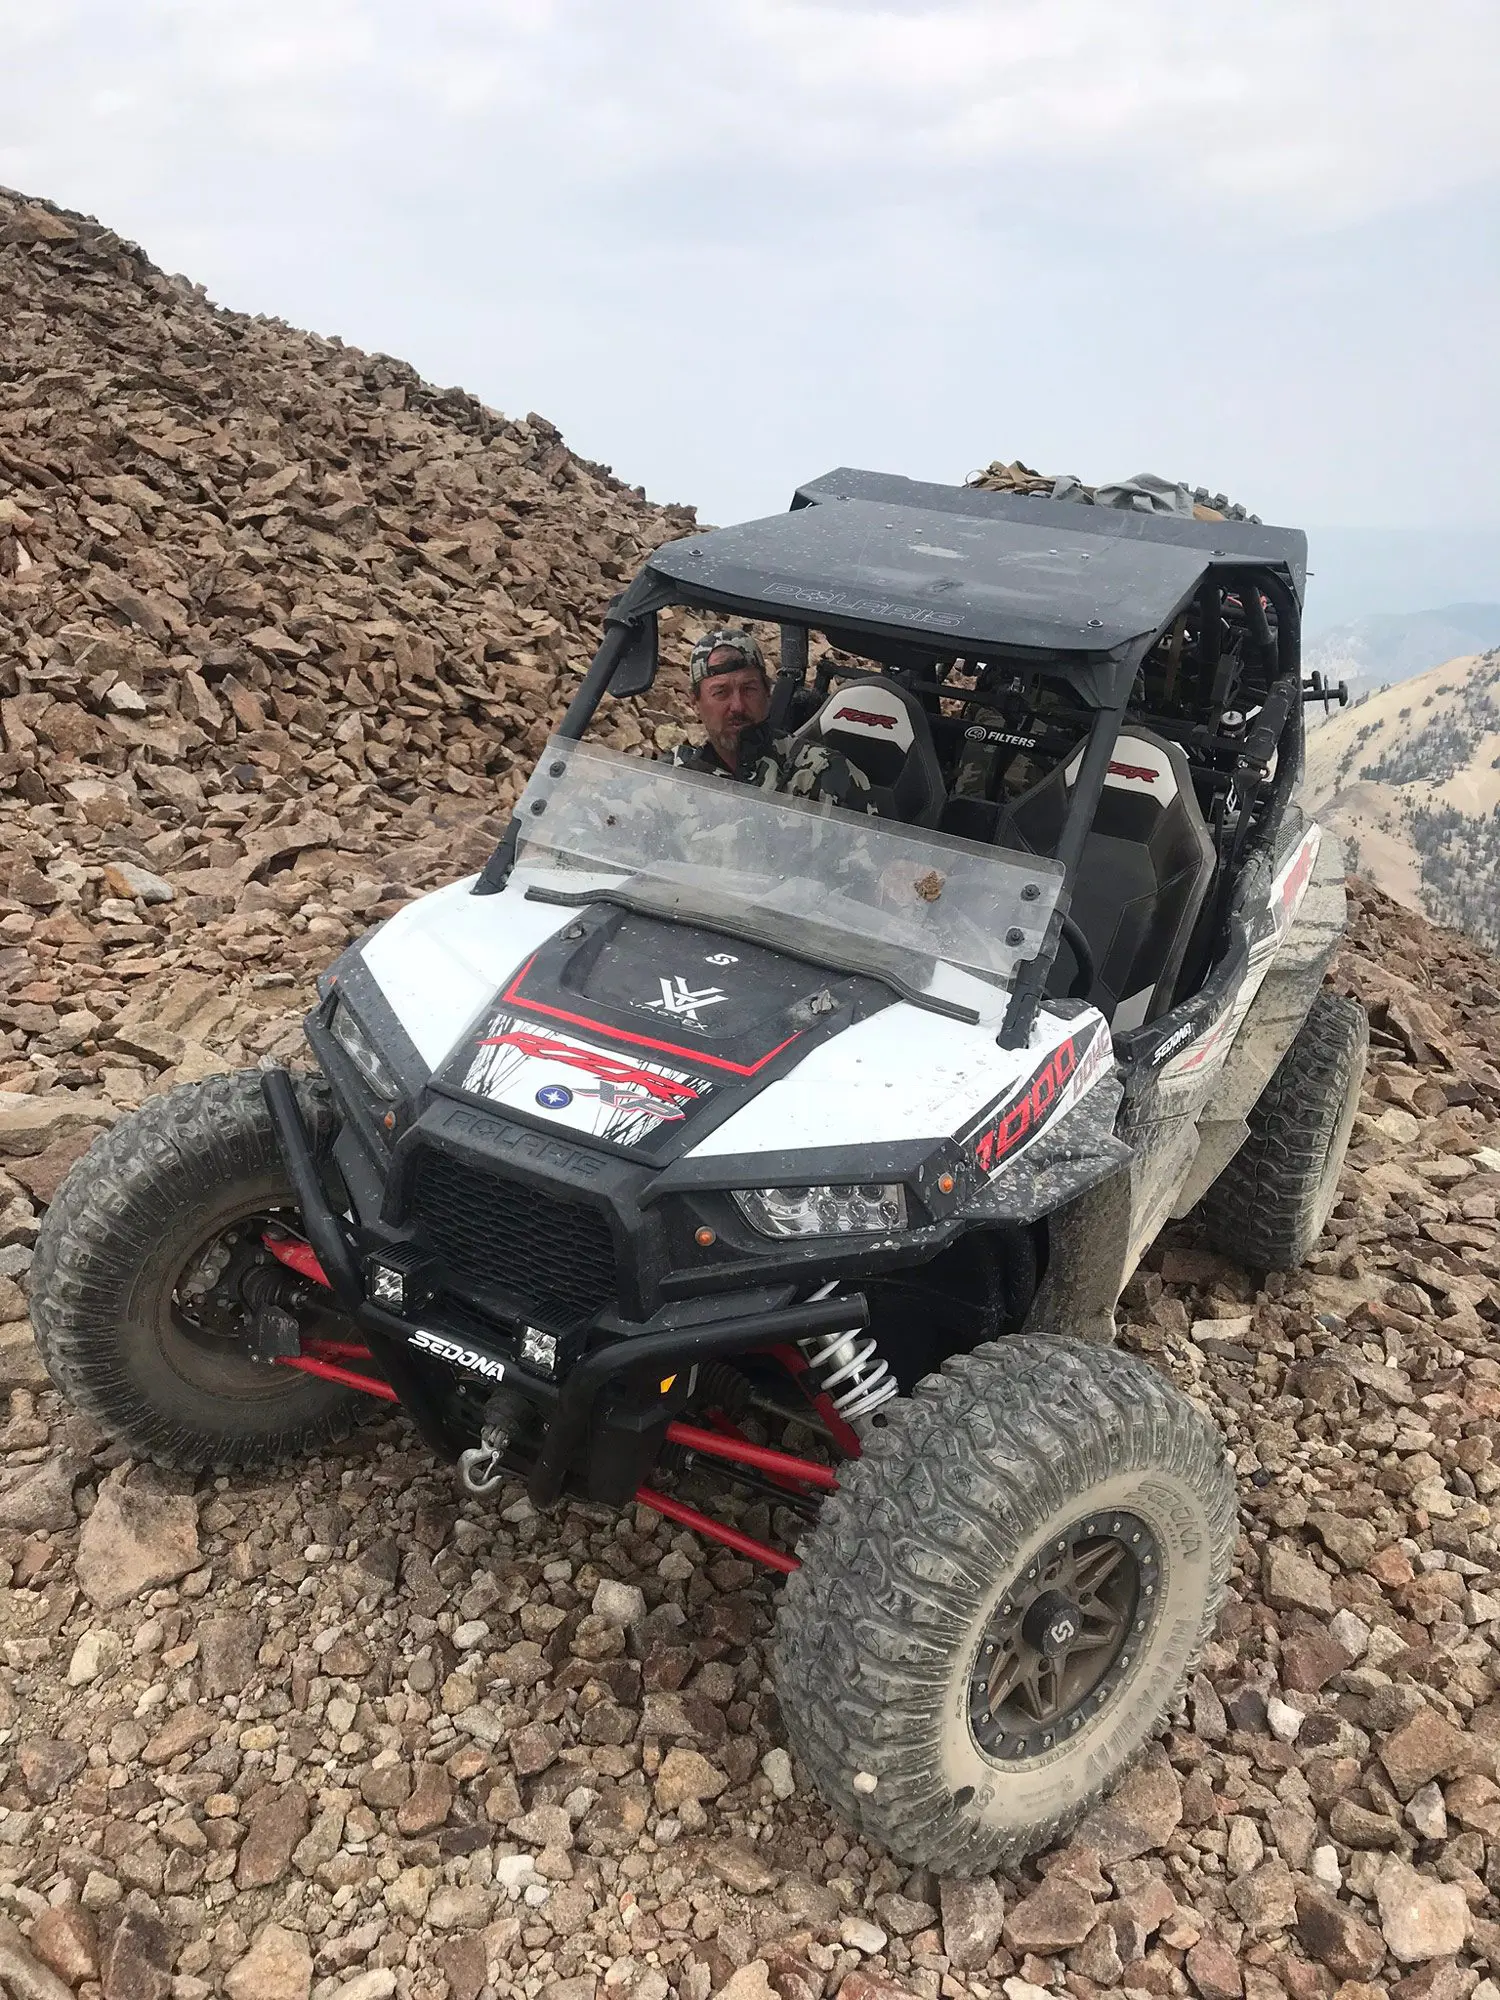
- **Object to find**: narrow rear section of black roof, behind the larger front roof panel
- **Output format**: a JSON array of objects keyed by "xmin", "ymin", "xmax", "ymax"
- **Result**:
[{"xmin": 792, "ymin": 466, "xmax": 1308, "ymax": 602}]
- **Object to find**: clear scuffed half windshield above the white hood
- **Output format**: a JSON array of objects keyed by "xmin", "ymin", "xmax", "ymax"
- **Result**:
[{"xmin": 516, "ymin": 738, "xmax": 1062, "ymax": 988}]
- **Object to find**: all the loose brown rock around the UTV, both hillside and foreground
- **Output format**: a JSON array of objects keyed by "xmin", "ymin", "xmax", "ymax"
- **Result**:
[{"xmin": 0, "ymin": 198, "xmax": 1500, "ymax": 2000}]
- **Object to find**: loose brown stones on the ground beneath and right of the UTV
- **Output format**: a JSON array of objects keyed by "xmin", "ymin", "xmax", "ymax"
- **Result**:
[{"xmin": 0, "ymin": 892, "xmax": 1500, "ymax": 2000}]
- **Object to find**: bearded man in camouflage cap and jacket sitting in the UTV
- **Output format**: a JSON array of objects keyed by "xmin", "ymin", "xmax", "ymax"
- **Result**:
[{"xmin": 672, "ymin": 626, "xmax": 876, "ymax": 812}]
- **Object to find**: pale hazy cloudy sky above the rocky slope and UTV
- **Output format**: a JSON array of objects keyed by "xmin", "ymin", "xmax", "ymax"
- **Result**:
[{"xmin": 0, "ymin": 0, "xmax": 1500, "ymax": 608}]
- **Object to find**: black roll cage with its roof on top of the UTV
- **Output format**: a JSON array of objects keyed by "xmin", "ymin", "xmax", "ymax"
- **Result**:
[{"xmin": 474, "ymin": 468, "xmax": 1342, "ymax": 1054}]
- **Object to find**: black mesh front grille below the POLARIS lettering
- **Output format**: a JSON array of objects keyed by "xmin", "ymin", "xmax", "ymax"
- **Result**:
[{"xmin": 412, "ymin": 1150, "xmax": 616, "ymax": 1328}]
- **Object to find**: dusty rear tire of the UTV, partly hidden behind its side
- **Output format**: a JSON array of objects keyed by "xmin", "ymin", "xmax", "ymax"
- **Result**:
[{"xmin": 1202, "ymin": 988, "xmax": 1370, "ymax": 1270}]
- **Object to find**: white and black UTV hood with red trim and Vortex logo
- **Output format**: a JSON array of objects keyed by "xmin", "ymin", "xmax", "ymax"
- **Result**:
[{"xmin": 360, "ymin": 868, "xmax": 1110, "ymax": 1182}]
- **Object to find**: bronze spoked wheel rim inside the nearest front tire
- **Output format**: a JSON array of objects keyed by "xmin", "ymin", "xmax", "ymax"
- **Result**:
[{"xmin": 968, "ymin": 1510, "xmax": 1160, "ymax": 1762}]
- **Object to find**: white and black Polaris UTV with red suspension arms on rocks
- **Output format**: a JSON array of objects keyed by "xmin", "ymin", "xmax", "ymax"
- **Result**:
[{"xmin": 32, "ymin": 472, "xmax": 1366, "ymax": 1874}]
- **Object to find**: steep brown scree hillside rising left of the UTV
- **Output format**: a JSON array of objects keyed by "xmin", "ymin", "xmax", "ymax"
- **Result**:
[{"xmin": 0, "ymin": 190, "xmax": 692, "ymax": 1194}]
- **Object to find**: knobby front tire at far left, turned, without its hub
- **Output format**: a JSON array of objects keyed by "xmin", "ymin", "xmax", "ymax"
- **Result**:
[{"xmin": 30, "ymin": 1070, "xmax": 360, "ymax": 1470}]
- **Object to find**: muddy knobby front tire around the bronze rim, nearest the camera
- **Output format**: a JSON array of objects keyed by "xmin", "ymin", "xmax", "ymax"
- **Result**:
[{"xmin": 776, "ymin": 1338, "xmax": 1236, "ymax": 1876}]
